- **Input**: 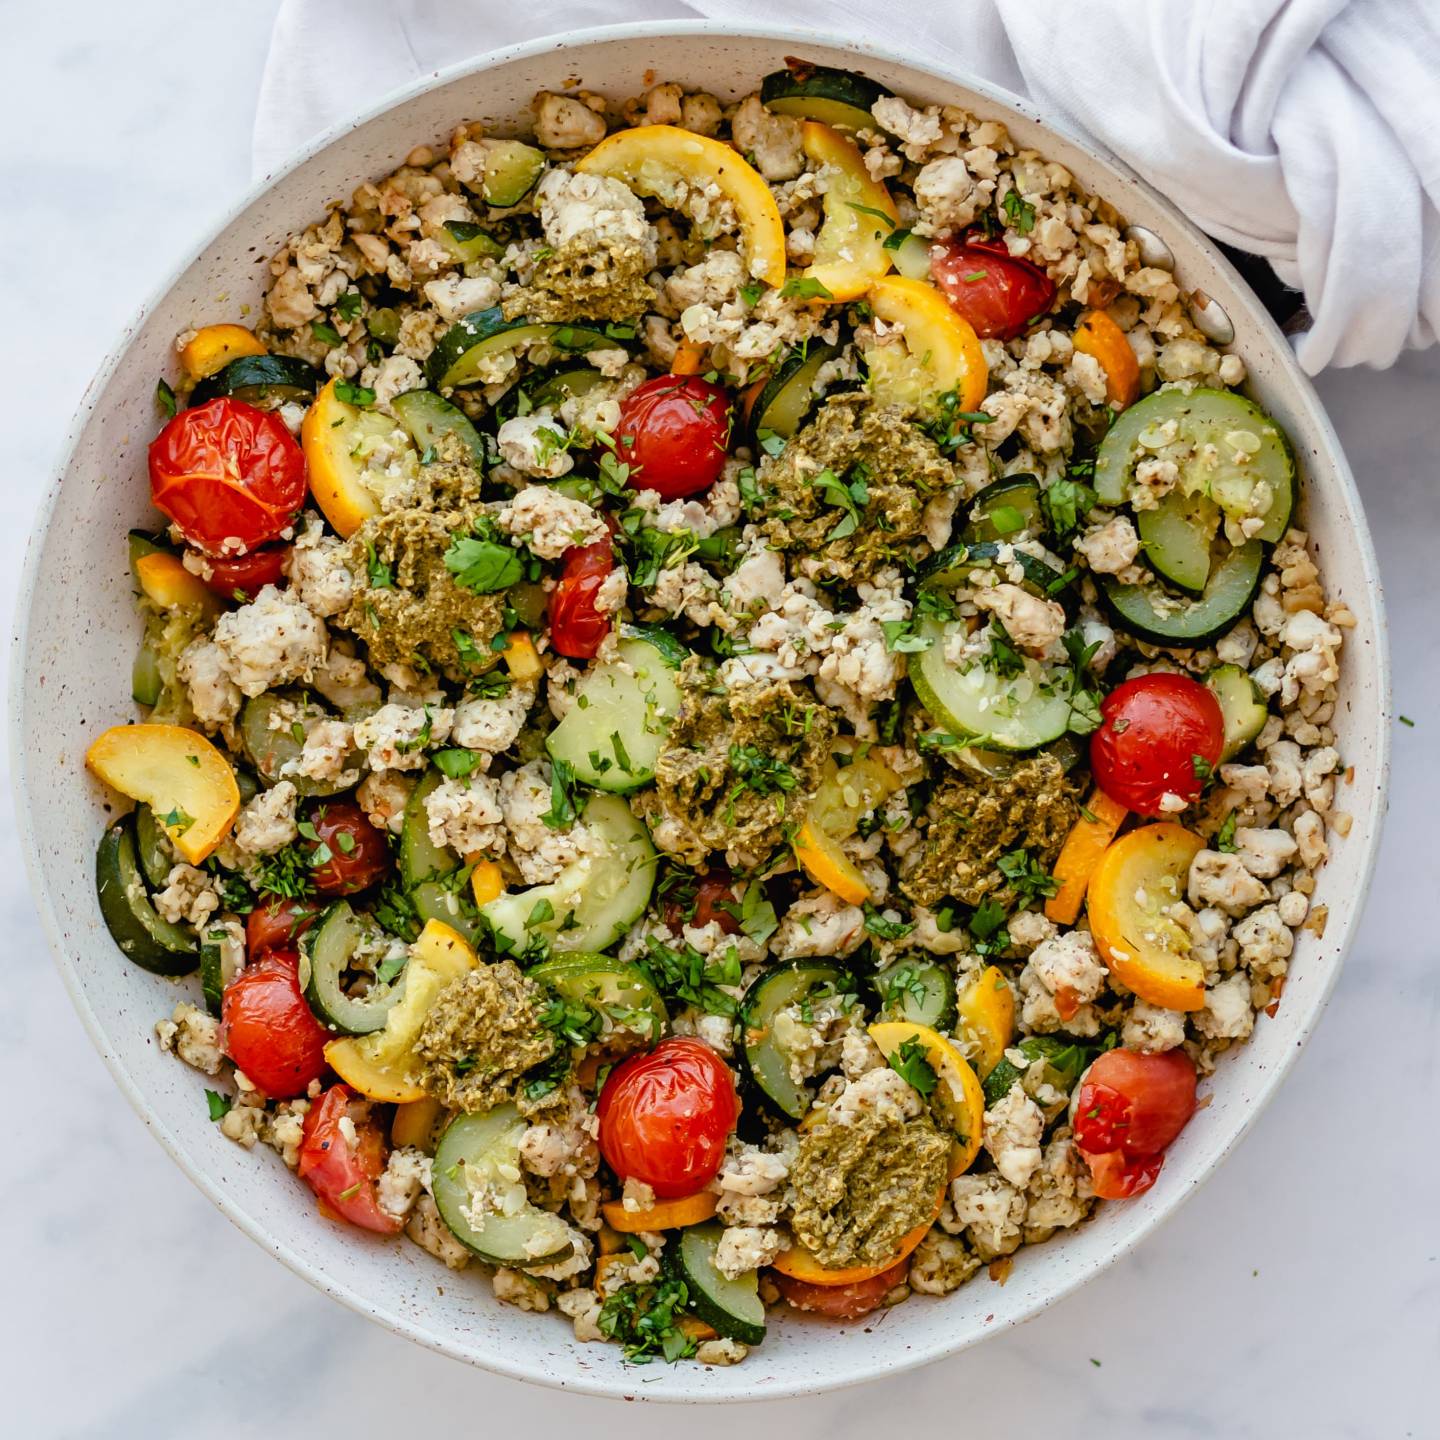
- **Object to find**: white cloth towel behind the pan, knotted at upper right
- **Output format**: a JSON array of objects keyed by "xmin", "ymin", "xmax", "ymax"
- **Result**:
[{"xmin": 255, "ymin": 0, "xmax": 1440, "ymax": 374}]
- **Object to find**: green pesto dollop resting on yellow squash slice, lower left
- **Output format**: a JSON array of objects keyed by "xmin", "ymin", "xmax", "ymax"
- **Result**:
[{"xmin": 415, "ymin": 960, "xmax": 554, "ymax": 1112}]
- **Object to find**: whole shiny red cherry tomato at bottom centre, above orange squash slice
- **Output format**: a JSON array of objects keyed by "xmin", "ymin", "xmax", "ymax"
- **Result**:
[{"xmin": 596, "ymin": 1038, "xmax": 740, "ymax": 1200}]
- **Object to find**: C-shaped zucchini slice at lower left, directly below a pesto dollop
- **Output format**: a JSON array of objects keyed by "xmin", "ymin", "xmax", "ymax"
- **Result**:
[{"xmin": 433, "ymin": 1103, "xmax": 575, "ymax": 1270}]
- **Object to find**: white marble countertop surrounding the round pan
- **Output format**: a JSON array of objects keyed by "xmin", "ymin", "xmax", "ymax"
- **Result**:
[{"xmin": 0, "ymin": 0, "xmax": 1440, "ymax": 1440}]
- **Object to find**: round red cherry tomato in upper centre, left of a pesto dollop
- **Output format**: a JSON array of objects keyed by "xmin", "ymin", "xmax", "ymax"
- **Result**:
[{"xmin": 616, "ymin": 374, "xmax": 730, "ymax": 500}]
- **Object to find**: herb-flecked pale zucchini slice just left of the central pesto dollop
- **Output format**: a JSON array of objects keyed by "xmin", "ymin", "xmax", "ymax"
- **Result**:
[{"xmin": 546, "ymin": 632, "xmax": 680, "ymax": 792}]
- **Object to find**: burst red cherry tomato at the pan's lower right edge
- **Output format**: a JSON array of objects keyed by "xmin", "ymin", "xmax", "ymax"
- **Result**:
[{"xmin": 1074, "ymin": 1050, "xmax": 1195, "ymax": 1200}]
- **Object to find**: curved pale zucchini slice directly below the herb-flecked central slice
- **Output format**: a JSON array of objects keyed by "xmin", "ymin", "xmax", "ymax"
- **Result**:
[{"xmin": 480, "ymin": 795, "xmax": 655, "ymax": 955}]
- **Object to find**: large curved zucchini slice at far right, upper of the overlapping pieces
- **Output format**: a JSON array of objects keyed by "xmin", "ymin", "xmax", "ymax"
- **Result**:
[{"xmin": 1094, "ymin": 389, "xmax": 1295, "ymax": 544}]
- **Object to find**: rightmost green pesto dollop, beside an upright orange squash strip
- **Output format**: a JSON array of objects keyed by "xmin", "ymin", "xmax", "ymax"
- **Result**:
[{"xmin": 900, "ymin": 753, "xmax": 1080, "ymax": 906}]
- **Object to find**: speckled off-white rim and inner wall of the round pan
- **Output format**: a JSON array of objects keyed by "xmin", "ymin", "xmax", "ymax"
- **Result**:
[{"xmin": 10, "ymin": 23, "xmax": 1388, "ymax": 1400}]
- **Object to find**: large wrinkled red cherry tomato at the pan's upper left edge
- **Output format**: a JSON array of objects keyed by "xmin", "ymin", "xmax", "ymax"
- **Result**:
[{"xmin": 150, "ymin": 396, "xmax": 305, "ymax": 556}]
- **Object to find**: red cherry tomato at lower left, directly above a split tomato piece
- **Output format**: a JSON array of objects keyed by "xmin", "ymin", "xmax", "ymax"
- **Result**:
[{"xmin": 220, "ymin": 950, "xmax": 333, "ymax": 1100}]
